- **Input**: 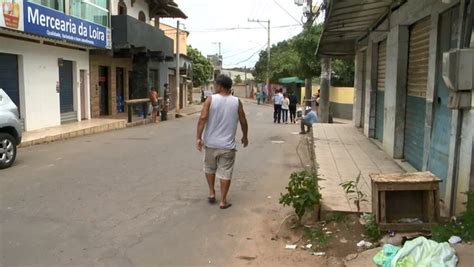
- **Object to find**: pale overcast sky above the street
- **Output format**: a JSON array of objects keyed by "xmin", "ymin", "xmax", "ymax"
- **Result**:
[{"xmin": 162, "ymin": 0, "xmax": 314, "ymax": 67}]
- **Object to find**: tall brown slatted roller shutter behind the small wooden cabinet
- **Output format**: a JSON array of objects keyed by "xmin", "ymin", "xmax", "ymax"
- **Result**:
[{"xmin": 403, "ymin": 17, "xmax": 430, "ymax": 170}]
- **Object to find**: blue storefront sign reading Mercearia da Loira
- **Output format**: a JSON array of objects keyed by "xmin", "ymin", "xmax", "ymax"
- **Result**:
[{"xmin": 0, "ymin": 0, "xmax": 112, "ymax": 49}]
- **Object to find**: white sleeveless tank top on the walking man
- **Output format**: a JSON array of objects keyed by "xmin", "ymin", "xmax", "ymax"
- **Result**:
[{"xmin": 204, "ymin": 94, "xmax": 239, "ymax": 149}]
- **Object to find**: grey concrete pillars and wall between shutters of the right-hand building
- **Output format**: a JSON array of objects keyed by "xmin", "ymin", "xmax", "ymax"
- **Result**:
[{"xmin": 354, "ymin": 0, "xmax": 474, "ymax": 213}]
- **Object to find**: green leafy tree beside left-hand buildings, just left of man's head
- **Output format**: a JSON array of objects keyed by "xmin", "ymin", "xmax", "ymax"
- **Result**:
[{"xmin": 188, "ymin": 45, "xmax": 214, "ymax": 87}]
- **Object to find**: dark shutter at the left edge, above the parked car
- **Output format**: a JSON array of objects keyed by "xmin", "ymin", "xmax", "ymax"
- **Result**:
[{"xmin": 0, "ymin": 53, "xmax": 20, "ymax": 107}]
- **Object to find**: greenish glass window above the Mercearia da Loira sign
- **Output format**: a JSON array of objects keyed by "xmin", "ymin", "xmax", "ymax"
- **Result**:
[{"xmin": 70, "ymin": 0, "xmax": 109, "ymax": 27}]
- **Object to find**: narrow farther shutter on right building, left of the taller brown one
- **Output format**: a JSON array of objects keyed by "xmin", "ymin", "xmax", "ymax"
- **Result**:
[{"xmin": 375, "ymin": 40, "xmax": 387, "ymax": 140}]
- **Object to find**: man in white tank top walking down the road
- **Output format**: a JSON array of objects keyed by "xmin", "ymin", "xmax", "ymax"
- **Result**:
[{"xmin": 196, "ymin": 75, "xmax": 249, "ymax": 209}]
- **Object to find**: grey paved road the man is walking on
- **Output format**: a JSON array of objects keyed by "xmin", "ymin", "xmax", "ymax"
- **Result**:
[{"xmin": 0, "ymin": 103, "xmax": 316, "ymax": 267}]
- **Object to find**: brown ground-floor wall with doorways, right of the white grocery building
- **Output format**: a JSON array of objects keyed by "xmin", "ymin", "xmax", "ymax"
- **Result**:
[{"xmin": 89, "ymin": 55, "xmax": 133, "ymax": 118}]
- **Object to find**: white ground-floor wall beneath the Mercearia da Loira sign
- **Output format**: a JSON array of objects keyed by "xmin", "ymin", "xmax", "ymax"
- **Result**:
[{"xmin": 0, "ymin": 37, "xmax": 91, "ymax": 131}]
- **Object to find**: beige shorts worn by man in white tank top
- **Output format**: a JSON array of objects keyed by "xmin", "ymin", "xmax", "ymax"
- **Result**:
[{"xmin": 204, "ymin": 147, "xmax": 236, "ymax": 180}]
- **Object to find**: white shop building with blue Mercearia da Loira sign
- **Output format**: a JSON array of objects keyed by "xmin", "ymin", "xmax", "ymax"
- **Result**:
[{"xmin": 0, "ymin": 0, "xmax": 111, "ymax": 131}]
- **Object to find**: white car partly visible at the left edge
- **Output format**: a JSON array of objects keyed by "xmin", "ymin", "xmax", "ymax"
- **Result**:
[{"xmin": 0, "ymin": 88, "xmax": 22, "ymax": 169}]
